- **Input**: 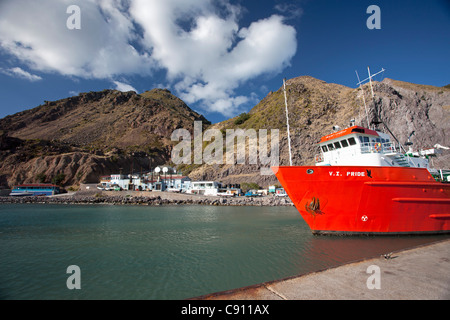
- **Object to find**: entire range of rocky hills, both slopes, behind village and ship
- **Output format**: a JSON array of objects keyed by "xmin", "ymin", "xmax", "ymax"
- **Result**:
[{"xmin": 0, "ymin": 76, "xmax": 450, "ymax": 186}]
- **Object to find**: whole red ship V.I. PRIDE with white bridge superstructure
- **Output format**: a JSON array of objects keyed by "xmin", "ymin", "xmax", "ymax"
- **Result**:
[{"xmin": 272, "ymin": 125, "xmax": 450, "ymax": 235}]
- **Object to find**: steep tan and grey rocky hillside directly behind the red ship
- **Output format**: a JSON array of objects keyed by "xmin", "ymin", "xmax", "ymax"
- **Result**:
[{"xmin": 190, "ymin": 76, "xmax": 450, "ymax": 186}]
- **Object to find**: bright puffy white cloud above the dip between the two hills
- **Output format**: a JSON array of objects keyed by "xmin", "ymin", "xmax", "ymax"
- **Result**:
[{"xmin": 130, "ymin": 0, "xmax": 297, "ymax": 116}]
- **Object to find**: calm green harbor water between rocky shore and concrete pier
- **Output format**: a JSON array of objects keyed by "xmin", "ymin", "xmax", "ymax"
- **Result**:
[{"xmin": 0, "ymin": 204, "xmax": 449, "ymax": 300}]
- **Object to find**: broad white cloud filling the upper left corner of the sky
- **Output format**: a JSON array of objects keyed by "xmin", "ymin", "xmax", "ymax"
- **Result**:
[{"xmin": 0, "ymin": 0, "xmax": 153, "ymax": 78}]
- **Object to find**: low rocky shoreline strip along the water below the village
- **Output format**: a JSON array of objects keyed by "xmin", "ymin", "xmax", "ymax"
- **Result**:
[{"xmin": 0, "ymin": 192, "xmax": 293, "ymax": 206}]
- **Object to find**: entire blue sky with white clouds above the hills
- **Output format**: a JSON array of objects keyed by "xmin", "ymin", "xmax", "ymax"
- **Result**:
[{"xmin": 0, "ymin": 0, "xmax": 450, "ymax": 122}]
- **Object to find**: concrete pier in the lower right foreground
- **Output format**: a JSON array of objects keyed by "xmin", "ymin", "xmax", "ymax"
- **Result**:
[{"xmin": 194, "ymin": 239, "xmax": 450, "ymax": 300}]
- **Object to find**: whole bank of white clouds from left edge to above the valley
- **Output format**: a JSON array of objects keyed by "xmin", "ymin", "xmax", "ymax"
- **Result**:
[{"xmin": 0, "ymin": 0, "xmax": 297, "ymax": 116}]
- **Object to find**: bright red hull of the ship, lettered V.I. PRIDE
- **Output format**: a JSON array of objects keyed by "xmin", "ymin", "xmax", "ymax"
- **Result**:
[{"xmin": 272, "ymin": 166, "xmax": 450, "ymax": 234}]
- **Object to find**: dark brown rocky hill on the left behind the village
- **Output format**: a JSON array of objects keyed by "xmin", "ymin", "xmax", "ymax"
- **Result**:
[{"xmin": 0, "ymin": 89, "xmax": 208, "ymax": 186}]
